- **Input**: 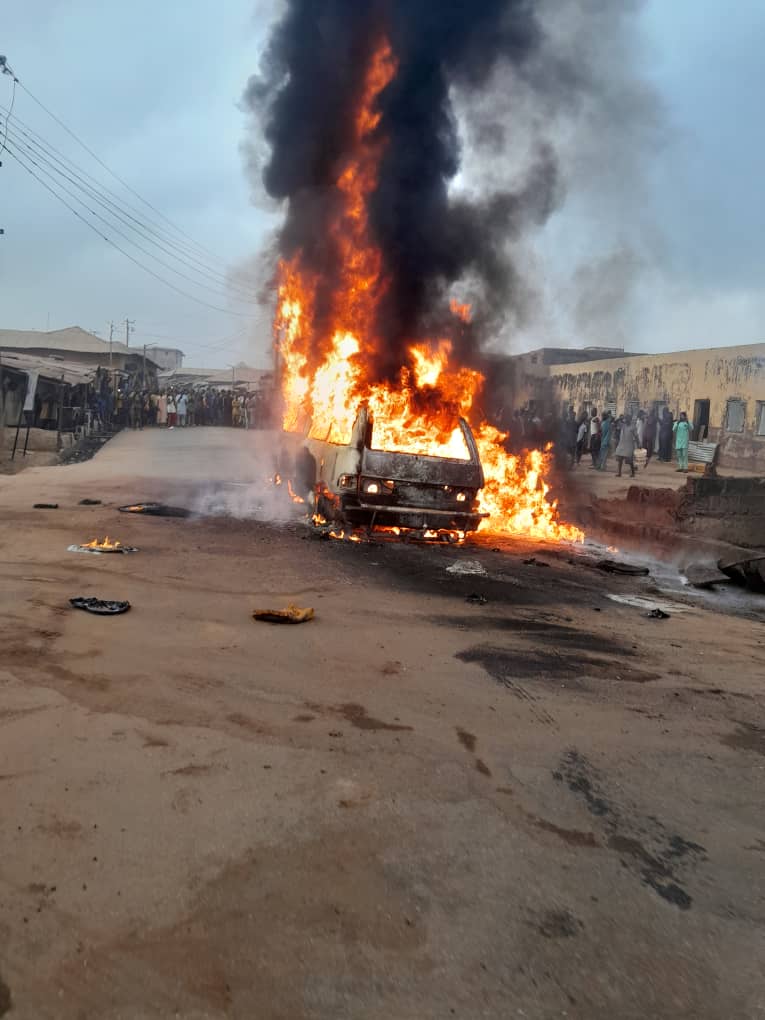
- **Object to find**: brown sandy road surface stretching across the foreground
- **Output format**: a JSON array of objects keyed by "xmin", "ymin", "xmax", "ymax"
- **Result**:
[{"xmin": 0, "ymin": 429, "xmax": 765, "ymax": 1020}]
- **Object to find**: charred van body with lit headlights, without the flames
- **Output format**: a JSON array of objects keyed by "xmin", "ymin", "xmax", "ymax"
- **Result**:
[{"xmin": 285, "ymin": 408, "xmax": 487, "ymax": 532}]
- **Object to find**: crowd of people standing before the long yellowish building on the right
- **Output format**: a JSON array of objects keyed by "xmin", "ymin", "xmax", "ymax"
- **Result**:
[{"xmin": 555, "ymin": 407, "xmax": 693, "ymax": 477}]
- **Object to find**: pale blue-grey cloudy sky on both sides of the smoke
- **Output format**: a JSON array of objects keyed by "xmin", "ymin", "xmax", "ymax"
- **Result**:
[{"xmin": 0, "ymin": 0, "xmax": 765, "ymax": 367}]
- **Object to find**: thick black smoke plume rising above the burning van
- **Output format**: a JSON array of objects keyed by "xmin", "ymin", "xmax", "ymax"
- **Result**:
[{"xmin": 245, "ymin": 0, "xmax": 618, "ymax": 378}]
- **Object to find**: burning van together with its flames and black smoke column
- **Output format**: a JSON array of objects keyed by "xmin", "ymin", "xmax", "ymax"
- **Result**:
[{"xmin": 245, "ymin": 0, "xmax": 583, "ymax": 541}]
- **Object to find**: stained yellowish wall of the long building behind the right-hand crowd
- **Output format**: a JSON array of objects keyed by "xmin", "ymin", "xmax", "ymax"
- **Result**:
[{"xmin": 549, "ymin": 344, "xmax": 765, "ymax": 473}]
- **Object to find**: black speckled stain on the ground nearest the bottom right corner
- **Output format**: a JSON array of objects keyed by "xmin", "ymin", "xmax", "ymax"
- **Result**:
[{"xmin": 553, "ymin": 751, "xmax": 706, "ymax": 910}]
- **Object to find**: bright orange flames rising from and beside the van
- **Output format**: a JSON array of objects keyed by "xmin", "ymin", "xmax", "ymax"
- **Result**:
[{"xmin": 273, "ymin": 41, "xmax": 583, "ymax": 541}]
